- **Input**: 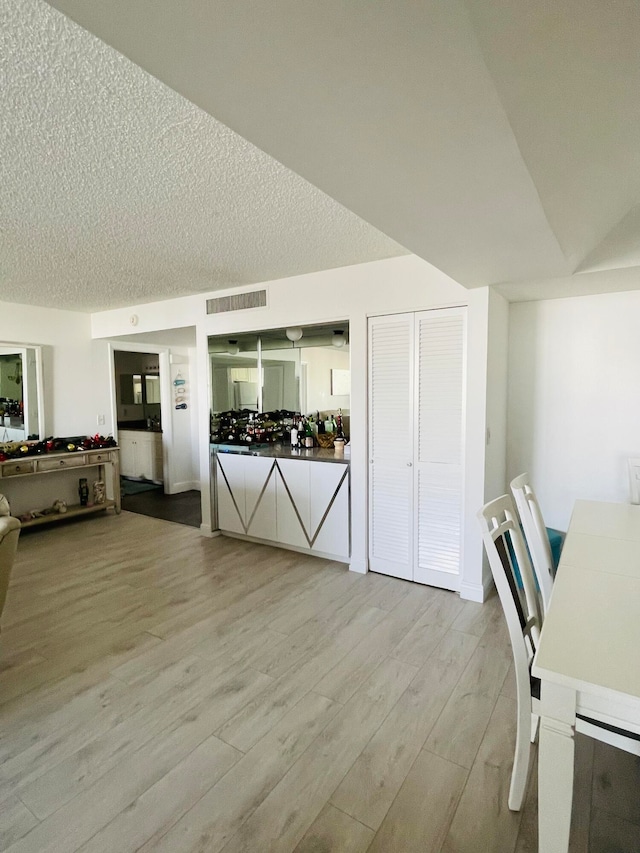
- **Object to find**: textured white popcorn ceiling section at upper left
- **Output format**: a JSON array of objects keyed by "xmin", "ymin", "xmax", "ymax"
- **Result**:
[{"xmin": 0, "ymin": 0, "xmax": 406, "ymax": 311}]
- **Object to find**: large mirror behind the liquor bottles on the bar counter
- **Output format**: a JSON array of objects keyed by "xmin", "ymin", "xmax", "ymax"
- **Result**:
[{"xmin": 209, "ymin": 321, "xmax": 350, "ymax": 442}]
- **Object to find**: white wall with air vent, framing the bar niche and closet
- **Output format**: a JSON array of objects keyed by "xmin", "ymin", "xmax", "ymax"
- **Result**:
[{"xmin": 92, "ymin": 255, "xmax": 490, "ymax": 599}]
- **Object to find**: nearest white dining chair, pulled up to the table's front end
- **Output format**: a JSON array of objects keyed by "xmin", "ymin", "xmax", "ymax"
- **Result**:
[{"xmin": 478, "ymin": 495, "xmax": 640, "ymax": 811}]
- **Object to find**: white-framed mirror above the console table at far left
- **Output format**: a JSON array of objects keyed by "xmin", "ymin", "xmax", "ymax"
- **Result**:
[{"xmin": 0, "ymin": 343, "xmax": 45, "ymax": 443}]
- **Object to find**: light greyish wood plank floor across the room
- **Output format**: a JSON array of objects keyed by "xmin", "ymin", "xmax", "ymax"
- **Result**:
[{"xmin": 0, "ymin": 513, "xmax": 640, "ymax": 853}]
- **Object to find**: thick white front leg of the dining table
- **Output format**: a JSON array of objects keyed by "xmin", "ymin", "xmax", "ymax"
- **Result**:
[{"xmin": 538, "ymin": 686, "xmax": 575, "ymax": 853}]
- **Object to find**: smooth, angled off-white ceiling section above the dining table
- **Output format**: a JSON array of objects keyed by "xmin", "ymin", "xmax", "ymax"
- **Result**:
[{"xmin": 48, "ymin": 0, "xmax": 640, "ymax": 298}]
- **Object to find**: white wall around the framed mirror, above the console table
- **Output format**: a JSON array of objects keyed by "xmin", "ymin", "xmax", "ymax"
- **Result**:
[{"xmin": 0, "ymin": 302, "xmax": 110, "ymax": 436}]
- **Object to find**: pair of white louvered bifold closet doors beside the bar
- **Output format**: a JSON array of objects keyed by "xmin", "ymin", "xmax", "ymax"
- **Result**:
[{"xmin": 369, "ymin": 308, "xmax": 466, "ymax": 589}]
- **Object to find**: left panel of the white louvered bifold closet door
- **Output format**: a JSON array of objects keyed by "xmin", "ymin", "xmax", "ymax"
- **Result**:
[{"xmin": 369, "ymin": 314, "xmax": 414, "ymax": 580}]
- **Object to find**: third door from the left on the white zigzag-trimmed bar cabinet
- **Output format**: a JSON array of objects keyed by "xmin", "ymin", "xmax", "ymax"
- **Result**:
[{"xmin": 276, "ymin": 459, "xmax": 312, "ymax": 548}]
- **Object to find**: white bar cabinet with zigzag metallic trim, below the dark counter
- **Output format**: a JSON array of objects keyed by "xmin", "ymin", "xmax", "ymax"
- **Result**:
[{"xmin": 216, "ymin": 453, "xmax": 350, "ymax": 562}]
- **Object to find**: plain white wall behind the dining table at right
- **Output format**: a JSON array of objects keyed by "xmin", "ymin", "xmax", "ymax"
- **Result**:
[{"xmin": 507, "ymin": 291, "xmax": 640, "ymax": 530}]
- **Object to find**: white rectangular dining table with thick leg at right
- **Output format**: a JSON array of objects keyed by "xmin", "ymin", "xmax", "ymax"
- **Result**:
[{"xmin": 532, "ymin": 500, "xmax": 640, "ymax": 853}]
